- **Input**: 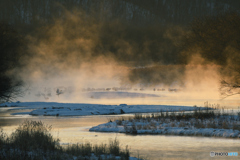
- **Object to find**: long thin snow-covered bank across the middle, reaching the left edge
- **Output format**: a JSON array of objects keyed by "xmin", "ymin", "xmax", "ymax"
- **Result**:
[{"xmin": 1, "ymin": 102, "xmax": 205, "ymax": 116}]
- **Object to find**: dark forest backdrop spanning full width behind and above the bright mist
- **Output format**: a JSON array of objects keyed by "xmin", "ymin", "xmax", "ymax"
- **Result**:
[{"xmin": 0, "ymin": 0, "xmax": 240, "ymax": 100}]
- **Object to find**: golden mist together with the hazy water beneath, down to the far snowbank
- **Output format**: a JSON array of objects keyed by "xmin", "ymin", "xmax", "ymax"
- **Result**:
[{"xmin": 14, "ymin": 10, "xmax": 238, "ymax": 106}]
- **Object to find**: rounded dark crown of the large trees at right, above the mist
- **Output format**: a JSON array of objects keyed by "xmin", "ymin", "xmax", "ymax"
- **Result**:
[{"xmin": 182, "ymin": 12, "xmax": 240, "ymax": 66}]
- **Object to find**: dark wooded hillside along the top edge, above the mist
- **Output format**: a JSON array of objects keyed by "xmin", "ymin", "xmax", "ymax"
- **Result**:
[{"xmin": 0, "ymin": 0, "xmax": 240, "ymax": 25}]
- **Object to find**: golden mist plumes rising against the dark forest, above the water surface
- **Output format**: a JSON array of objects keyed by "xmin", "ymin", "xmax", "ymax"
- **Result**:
[{"xmin": 1, "ymin": 4, "xmax": 239, "ymax": 105}]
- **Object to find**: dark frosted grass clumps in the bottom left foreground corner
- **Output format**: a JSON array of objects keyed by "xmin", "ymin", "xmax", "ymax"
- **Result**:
[{"xmin": 0, "ymin": 120, "xmax": 134, "ymax": 160}]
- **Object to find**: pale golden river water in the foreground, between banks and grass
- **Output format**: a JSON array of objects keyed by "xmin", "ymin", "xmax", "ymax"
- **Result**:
[{"xmin": 0, "ymin": 107, "xmax": 240, "ymax": 160}]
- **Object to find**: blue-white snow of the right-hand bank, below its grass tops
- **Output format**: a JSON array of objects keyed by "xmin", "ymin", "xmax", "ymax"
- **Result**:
[{"xmin": 89, "ymin": 116, "xmax": 240, "ymax": 138}]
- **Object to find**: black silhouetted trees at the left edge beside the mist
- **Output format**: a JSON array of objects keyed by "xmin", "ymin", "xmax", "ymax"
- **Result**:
[{"xmin": 0, "ymin": 23, "xmax": 24, "ymax": 102}]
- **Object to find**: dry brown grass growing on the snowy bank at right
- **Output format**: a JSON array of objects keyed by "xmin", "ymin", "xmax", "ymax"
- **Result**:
[{"xmin": 110, "ymin": 108, "xmax": 240, "ymax": 134}]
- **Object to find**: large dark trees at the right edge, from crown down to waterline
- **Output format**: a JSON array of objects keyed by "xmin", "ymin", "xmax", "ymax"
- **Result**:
[{"xmin": 181, "ymin": 12, "xmax": 240, "ymax": 97}]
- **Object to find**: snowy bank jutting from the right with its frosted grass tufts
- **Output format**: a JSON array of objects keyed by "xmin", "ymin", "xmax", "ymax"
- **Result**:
[{"xmin": 90, "ymin": 108, "xmax": 240, "ymax": 138}]
